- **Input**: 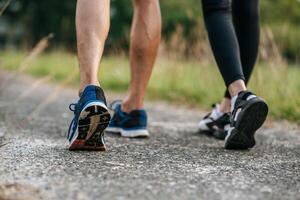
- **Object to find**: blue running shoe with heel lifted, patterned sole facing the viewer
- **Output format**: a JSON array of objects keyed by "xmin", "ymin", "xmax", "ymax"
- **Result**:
[{"xmin": 68, "ymin": 85, "xmax": 110, "ymax": 151}]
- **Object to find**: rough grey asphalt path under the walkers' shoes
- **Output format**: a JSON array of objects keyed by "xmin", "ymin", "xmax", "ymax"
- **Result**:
[{"xmin": 0, "ymin": 72, "xmax": 300, "ymax": 200}]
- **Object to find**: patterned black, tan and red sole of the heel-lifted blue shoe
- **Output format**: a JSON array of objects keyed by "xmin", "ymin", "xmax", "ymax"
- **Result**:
[{"xmin": 69, "ymin": 102, "xmax": 110, "ymax": 151}]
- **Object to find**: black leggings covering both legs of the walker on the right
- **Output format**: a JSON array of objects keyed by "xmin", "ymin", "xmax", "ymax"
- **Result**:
[{"xmin": 202, "ymin": 0, "xmax": 259, "ymax": 98}]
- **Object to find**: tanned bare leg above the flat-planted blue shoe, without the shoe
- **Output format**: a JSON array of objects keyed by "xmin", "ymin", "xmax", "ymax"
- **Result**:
[{"xmin": 122, "ymin": 0, "xmax": 161, "ymax": 112}]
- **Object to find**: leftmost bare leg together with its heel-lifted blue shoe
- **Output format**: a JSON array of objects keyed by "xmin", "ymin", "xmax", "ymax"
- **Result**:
[{"xmin": 67, "ymin": 0, "xmax": 110, "ymax": 151}]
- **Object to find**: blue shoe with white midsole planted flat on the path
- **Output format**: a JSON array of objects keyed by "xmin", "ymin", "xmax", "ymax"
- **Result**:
[{"xmin": 106, "ymin": 100, "xmax": 149, "ymax": 137}]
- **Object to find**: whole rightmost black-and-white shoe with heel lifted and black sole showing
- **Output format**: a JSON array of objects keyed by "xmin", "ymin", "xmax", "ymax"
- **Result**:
[{"xmin": 225, "ymin": 91, "xmax": 268, "ymax": 149}]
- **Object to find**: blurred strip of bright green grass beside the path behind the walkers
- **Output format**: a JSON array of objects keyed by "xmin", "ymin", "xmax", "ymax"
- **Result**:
[{"xmin": 0, "ymin": 51, "xmax": 300, "ymax": 123}]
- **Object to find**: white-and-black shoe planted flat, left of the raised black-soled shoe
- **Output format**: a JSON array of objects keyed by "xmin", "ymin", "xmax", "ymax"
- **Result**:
[{"xmin": 198, "ymin": 104, "xmax": 230, "ymax": 140}]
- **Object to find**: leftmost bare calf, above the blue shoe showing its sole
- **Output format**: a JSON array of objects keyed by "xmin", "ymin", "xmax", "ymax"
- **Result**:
[{"xmin": 76, "ymin": 0, "xmax": 110, "ymax": 93}]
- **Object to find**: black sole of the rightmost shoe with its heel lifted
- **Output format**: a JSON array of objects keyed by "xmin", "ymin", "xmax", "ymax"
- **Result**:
[{"xmin": 225, "ymin": 99, "xmax": 268, "ymax": 150}]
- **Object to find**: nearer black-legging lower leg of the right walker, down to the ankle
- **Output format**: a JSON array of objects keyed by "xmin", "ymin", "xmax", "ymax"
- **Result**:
[{"xmin": 202, "ymin": 0, "xmax": 245, "ymax": 90}]
